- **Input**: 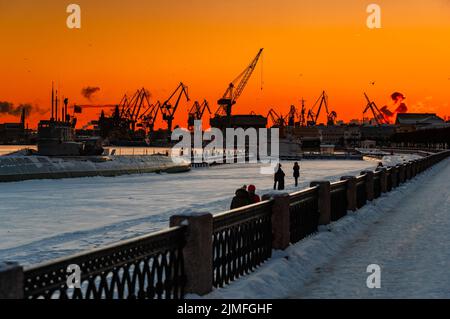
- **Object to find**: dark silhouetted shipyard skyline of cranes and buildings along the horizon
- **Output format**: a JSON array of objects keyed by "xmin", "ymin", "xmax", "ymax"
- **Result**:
[{"xmin": 0, "ymin": 48, "xmax": 448, "ymax": 153}]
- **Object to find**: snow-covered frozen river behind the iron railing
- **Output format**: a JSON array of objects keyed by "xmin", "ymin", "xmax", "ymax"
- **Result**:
[{"xmin": 0, "ymin": 159, "xmax": 414, "ymax": 264}]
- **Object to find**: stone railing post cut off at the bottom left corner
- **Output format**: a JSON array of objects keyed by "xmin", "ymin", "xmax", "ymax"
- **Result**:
[{"xmin": 0, "ymin": 262, "xmax": 24, "ymax": 299}]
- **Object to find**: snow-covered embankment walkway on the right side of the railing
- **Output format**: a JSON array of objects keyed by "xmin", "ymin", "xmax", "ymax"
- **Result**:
[{"xmin": 205, "ymin": 159, "xmax": 450, "ymax": 298}]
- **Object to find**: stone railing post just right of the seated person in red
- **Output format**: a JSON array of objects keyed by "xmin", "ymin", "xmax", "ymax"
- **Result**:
[{"xmin": 262, "ymin": 193, "xmax": 291, "ymax": 250}]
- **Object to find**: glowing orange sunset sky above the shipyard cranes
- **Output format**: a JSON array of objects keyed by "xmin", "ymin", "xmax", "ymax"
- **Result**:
[{"xmin": 0, "ymin": 0, "xmax": 450, "ymax": 127}]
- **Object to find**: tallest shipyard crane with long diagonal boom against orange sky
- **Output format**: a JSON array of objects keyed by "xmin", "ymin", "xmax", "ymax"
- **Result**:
[{"xmin": 215, "ymin": 49, "xmax": 264, "ymax": 123}]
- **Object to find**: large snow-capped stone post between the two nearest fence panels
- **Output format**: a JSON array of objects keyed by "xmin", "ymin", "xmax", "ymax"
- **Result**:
[{"xmin": 170, "ymin": 213, "xmax": 213, "ymax": 296}]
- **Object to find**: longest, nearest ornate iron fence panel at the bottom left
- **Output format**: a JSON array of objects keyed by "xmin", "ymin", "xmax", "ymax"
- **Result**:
[{"xmin": 24, "ymin": 227, "xmax": 185, "ymax": 299}]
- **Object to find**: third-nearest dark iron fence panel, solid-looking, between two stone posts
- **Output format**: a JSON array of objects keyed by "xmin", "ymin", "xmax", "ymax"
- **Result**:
[{"xmin": 289, "ymin": 186, "xmax": 319, "ymax": 243}]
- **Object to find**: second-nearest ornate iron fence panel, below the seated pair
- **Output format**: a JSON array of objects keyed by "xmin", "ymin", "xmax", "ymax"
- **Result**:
[{"xmin": 212, "ymin": 201, "xmax": 273, "ymax": 287}]
